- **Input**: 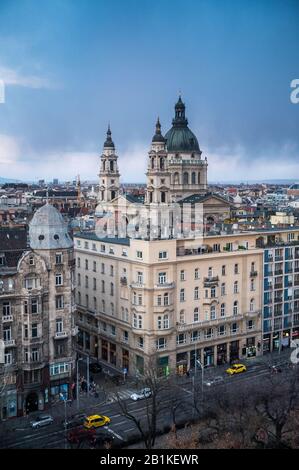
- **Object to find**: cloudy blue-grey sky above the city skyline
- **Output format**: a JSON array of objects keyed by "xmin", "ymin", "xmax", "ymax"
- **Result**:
[{"xmin": 0, "ymin": 0, "xmax": 299, "ymax": 182}]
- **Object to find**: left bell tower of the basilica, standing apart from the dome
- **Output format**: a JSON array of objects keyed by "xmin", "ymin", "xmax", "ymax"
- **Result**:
[{"xmin": 98, "ymin": 125, "xmax": 120, "ymax": 202}]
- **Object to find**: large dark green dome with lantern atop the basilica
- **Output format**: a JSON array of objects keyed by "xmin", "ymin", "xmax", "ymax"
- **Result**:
[{"xmin": 165, "ymin": 97, "xmax": 200, "ymax": 152}]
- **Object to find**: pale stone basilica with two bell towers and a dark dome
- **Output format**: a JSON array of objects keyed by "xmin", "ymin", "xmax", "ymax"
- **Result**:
[{"xmin": 96, "ymin": 96, "xmax": 230, "ymax": 237}]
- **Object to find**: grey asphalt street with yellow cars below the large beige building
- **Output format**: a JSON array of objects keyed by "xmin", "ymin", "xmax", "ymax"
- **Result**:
[{"xmin": 0, "ymin": 354, "xmax": 298, "ymax": 449}]
